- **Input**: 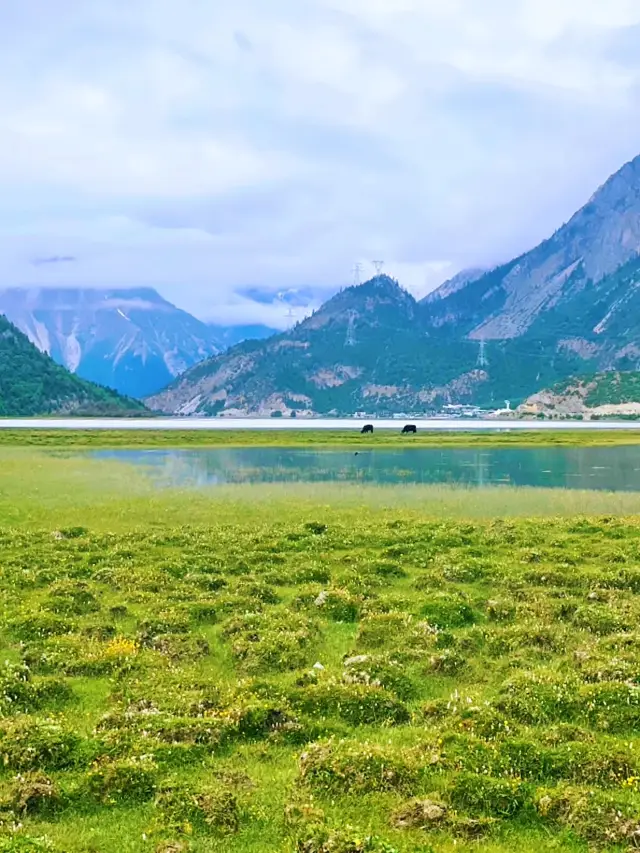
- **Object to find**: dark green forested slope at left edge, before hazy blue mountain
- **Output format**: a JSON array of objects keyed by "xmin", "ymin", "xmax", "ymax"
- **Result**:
[{"xmin": 0, "ymin": 316, "xmax": 144, "ymax": 417}]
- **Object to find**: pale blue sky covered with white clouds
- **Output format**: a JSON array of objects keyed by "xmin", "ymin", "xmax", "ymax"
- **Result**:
[{"xmin": 0, "ymin": 0, "xmax": 640, "ymax": 327}]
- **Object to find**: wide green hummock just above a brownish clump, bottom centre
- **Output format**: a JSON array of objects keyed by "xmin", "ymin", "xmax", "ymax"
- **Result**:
[{"xmin": 300, "ymin": 739, "xmax": 420, "ymax": 794}]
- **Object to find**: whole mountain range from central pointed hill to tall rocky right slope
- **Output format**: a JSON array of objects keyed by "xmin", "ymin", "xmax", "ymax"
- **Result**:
[{"xmin": 147, "ymin": 157, "xmax": 640, "ymax": 414}]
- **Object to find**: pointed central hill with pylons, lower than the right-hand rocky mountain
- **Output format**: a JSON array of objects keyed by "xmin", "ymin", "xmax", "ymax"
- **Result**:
[{"xmin": 147, "ymin": 275, "xmax": 482, "ymax": 415}]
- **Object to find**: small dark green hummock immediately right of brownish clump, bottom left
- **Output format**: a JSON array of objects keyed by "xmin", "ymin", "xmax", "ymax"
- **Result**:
[{"xmin": 86, "ymin": 756, "xmax": 157, "ymax": 803}]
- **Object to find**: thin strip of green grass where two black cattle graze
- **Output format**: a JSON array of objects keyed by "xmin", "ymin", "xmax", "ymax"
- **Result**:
[{"xmin": 0, "ymin": 422, "xmax": 640, "ymax": 449}]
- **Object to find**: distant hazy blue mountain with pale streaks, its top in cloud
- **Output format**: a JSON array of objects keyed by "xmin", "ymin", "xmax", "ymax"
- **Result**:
[{"xmin": 0, "ymin": 288, "xmax": 224, "ymax": 398}]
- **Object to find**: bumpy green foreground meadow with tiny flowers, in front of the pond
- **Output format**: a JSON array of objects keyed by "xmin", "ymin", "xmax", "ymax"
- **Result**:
[{"xmin": 0, "ymin": 433, "xmax": 640, "ymax": 853}]
